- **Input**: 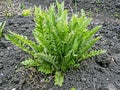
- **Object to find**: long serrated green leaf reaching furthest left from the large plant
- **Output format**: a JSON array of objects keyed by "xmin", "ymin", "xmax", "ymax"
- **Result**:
[{"xmin": 5, "ymin": 31, "xmax": 39, "ymax": 56}]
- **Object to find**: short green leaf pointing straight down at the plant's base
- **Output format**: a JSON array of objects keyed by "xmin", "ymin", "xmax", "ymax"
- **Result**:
[{"xmin": 55, "ymin": 72, "xmax": 64, "ymax": 87}]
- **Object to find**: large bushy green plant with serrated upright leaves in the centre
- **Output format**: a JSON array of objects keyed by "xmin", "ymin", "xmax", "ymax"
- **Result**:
[{"xmin": 5, "ymin": 2, "xmax": 105, "ymax": 86}]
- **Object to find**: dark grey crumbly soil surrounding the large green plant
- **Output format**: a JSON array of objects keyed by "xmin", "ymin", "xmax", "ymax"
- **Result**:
[{"xmin": 0, "ymin": 0, "xmax": 120, "ymax": 90}]
